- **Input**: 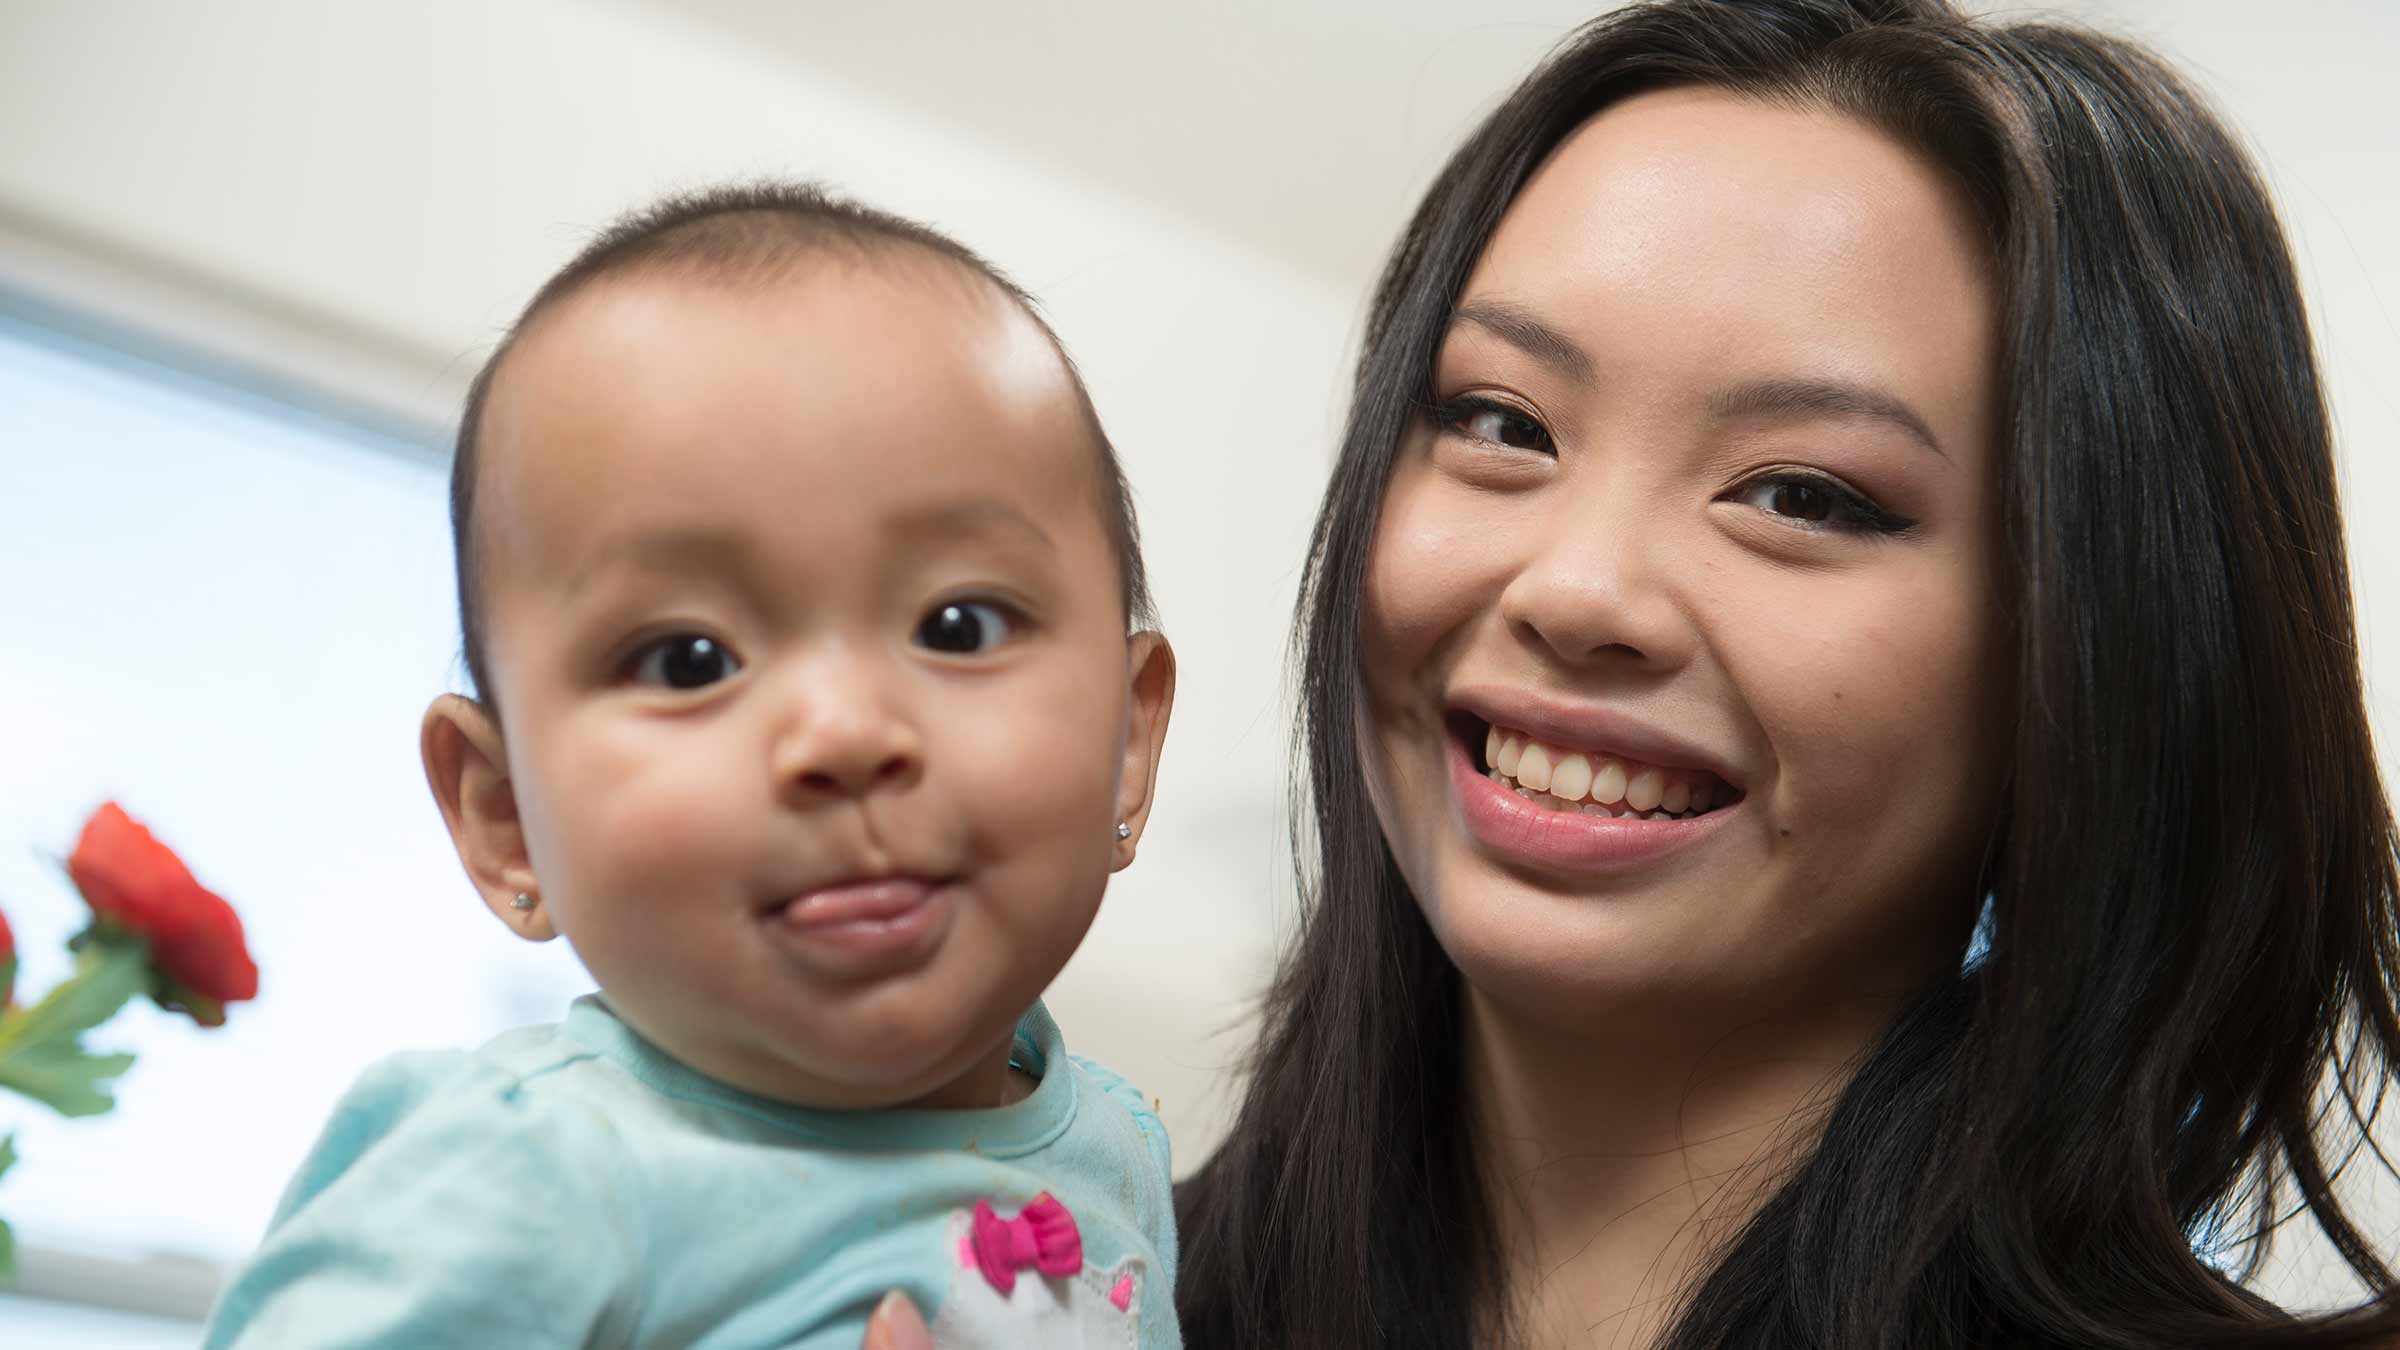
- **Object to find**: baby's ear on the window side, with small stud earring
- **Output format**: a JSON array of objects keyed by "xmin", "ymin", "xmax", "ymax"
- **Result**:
[{"xmin": 418, "ymin": 694, "xmax": 559, "ymax": 942}]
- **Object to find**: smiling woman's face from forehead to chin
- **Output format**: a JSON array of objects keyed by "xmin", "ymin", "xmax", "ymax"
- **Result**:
[{"xmin": 1363, "ymin": 91, "xmax": 2009, "ymax": 1026}]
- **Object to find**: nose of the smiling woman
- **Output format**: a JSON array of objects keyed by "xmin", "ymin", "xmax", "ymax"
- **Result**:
[{"xmin": 1500, "ymin": 500, "xmax": 1694, "ymax": 668}]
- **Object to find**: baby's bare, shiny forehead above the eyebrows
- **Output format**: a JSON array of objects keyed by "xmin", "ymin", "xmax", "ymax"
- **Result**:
[{"xmin": 480, "ymin": 259, "xmax": 1104, "ymax": 565}]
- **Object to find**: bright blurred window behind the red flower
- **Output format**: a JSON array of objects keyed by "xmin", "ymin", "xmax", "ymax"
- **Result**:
[{"xmin": 0, "ymin": 305, "xmax": 590, "ymax": 1340}]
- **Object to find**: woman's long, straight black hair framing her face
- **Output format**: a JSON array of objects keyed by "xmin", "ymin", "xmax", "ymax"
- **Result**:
[{"xmin": 1178, "ymin": 0, "xmax": 2400, "ymax": 1350}]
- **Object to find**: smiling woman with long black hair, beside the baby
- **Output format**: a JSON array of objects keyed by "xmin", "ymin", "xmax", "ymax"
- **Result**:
[{"xmin": 1181, "ymin": 0, "xmax": 2400, "ymax": 1350}]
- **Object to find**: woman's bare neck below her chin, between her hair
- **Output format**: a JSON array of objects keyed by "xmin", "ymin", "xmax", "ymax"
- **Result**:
[{"xmin": 1464, "ymin": 985, "xmax": 1898, "ymax": 1350}]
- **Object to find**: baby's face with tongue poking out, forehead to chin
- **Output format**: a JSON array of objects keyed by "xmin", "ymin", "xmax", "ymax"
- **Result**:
[{"xmin": 478, "ymin": 257, "xmax": 1164, "ymax": 1107}]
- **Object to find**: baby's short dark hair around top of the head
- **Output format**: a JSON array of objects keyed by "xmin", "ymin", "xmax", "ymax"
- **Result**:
[{"xmin": 451, "ymin": 183, "xmax": 1157, "ymax": 716}]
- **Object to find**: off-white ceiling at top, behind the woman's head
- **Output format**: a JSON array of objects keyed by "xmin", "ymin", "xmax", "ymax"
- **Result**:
[{"xmin": 643, "ymin": 0, "xmax": 2400, "ymax": 293}]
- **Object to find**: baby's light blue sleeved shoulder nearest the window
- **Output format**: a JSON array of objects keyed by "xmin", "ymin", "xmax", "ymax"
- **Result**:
[{"xmin": 209, "ymin": 1031, "xmax": 650, "ymax": 1345}]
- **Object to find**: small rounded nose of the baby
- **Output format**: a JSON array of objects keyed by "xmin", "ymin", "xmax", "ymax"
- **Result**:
[{"xmin": 773, "ymin": 658, "xmax": 924, "ymax": 798}]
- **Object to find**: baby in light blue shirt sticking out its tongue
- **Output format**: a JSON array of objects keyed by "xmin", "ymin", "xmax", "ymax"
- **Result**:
[{"xmin": 209, "ymin": 185, "xmax": 1178, "ymax": 1350}]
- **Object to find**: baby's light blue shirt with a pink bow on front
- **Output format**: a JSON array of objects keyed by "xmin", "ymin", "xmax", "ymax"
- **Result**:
[{"xmin": 206, "ymin": 997, "xmax": 1181, "ymax": 1350}]
